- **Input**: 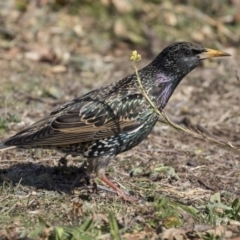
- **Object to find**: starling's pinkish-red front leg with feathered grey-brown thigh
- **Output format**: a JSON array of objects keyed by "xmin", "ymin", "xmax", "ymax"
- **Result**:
[{"xmin": 89, "ymin": 157, "xmax": 137, "ymax": 201}]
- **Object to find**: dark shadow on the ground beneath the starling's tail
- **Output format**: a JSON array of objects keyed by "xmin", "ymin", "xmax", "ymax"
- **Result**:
[{"xmin": 0, "ymin": 159, "xmax": 91, "ymax": 194}]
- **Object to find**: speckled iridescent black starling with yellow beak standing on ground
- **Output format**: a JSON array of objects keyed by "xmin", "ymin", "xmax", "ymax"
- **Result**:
[{"xmin": 0, "ymin": 42, "xmax": 229, "ymax": 200}]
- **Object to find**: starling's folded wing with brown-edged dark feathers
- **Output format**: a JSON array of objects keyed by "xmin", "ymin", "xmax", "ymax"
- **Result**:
[{"xmin": 4, "ymin": 94, "xmax": 146, "ymax": 146}]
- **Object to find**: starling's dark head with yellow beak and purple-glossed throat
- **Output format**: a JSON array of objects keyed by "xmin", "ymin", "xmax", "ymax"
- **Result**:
[{"xmin": 149, "ymin": 42, "xmax": 230, "ymax": 108}]
